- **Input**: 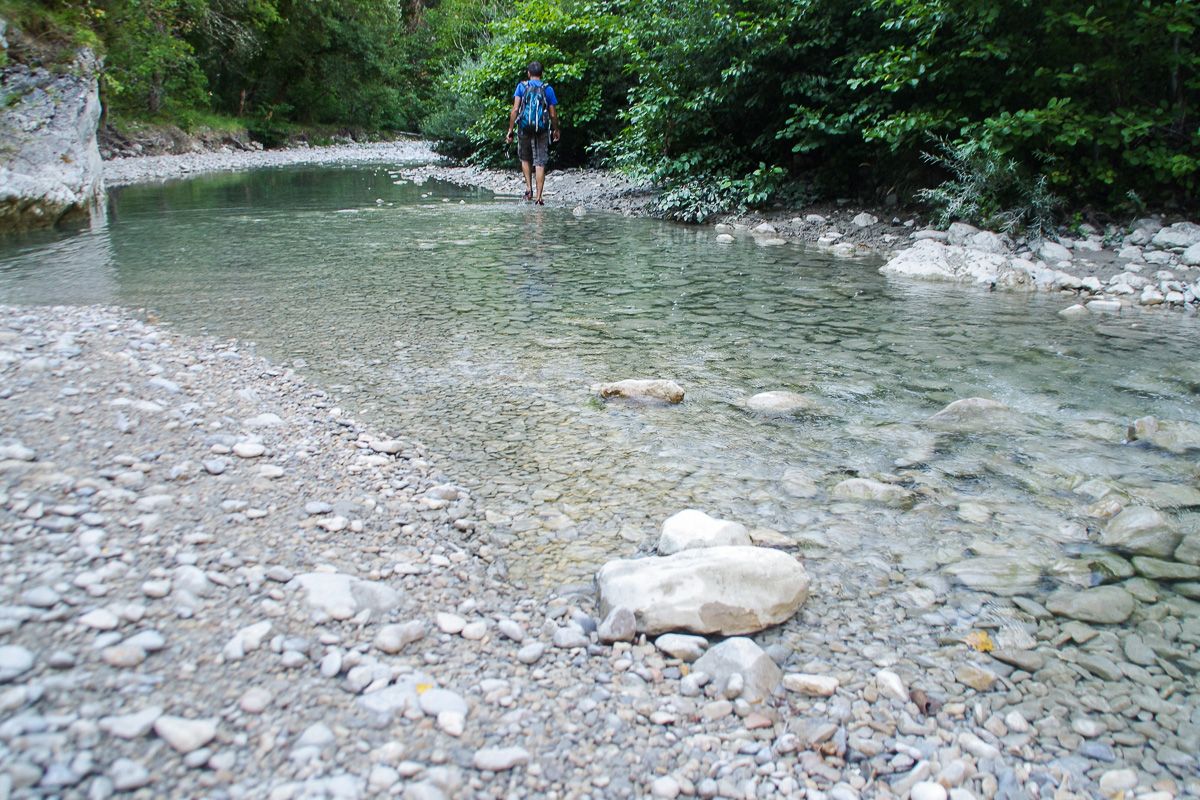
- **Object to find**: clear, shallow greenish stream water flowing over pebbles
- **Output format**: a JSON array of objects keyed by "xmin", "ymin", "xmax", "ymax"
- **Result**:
[{"xmin": 0, "ymin": 168, "xmax": 1200, "ymax": 587}]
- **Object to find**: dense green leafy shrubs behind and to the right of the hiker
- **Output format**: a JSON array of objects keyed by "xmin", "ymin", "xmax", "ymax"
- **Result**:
[{"xmin": 448, "ymin": 0, "xmax": 1200, "ymax": 227}]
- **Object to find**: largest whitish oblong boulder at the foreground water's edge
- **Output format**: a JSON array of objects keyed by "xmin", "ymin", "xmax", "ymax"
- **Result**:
[{"xmin": 596, "ymin": 547, "xmax": 809, "ymax": 636}]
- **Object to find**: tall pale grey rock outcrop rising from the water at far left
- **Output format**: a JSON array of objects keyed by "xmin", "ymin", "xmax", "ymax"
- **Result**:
[{"xmin": 0, "ymin": 49, "xmax": 103, "ymax": 233}]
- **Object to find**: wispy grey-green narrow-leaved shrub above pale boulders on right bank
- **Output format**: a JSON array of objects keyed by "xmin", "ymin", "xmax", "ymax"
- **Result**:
[{"xmin": 917, "ymin": 140, "xmax": 1061, "ymax": 239}]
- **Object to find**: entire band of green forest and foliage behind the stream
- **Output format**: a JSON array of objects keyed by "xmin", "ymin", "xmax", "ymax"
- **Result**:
[{"xmin": 0, "ymin": 0, "xmax": 1200, "ymax": 229}]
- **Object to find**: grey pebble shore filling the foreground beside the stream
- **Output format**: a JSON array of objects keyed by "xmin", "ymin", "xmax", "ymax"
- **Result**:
[{"xmin": 0, "ymin": 302, "xmax": 1200, "ymax": 800}]
